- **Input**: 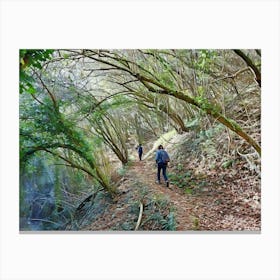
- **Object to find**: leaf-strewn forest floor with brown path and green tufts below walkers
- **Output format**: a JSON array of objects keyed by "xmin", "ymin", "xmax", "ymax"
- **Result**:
[{"xmin": 83, "ymin": 153, "xmax": 261, "ymax": 231}]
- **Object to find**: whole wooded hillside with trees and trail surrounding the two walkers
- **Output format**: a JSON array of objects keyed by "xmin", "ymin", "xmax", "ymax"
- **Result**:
[{"xmin": 19, "ymin": 49, "xmax": 261, "ymax": 232}]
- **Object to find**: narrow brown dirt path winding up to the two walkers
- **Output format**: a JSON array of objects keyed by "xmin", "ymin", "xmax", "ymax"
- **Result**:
[{"xmin": 129, "ymin": 160, "xmax": 195, "ymax": 231}]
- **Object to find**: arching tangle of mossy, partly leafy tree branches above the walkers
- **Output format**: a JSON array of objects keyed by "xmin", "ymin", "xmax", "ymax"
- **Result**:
[{"xmin": 19, "ymin": 49, "xmax": 261, "ymax": 231}]
